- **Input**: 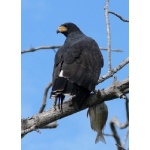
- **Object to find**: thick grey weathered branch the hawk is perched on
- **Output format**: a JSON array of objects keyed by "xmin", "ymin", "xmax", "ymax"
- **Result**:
[{"xmin": 22, "ymin": 78, "xmax": 129, "ymax": 136}]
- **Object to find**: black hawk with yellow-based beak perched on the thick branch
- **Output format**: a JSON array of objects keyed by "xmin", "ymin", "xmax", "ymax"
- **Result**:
[{"xmin": 50, "ymin": 23, "xmax": 104, "ymax": 109}]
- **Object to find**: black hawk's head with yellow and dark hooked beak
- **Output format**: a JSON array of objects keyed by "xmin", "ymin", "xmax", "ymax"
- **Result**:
[{"xmin": 57, "ymin": 22, "xmax": 80, "ymax": 37}]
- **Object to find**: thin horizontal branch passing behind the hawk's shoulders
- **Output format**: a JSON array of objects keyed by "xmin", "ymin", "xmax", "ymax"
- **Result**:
[{"xmin": 21, "ymin": 46, "xmax": 123, "ymax": 54}]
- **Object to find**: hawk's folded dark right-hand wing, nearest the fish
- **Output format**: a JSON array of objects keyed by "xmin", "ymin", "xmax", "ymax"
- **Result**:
[{"xmin": 62, "ymin": 38, "xmax": 103, "ymax": 91}]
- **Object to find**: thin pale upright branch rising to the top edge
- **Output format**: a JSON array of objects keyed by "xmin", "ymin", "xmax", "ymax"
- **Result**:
[{"xmin": 104, "ymin": 0, "xmax": 111, "ymax": 72}]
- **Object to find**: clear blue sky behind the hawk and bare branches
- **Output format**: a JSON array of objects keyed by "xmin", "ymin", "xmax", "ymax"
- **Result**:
[{"xmin": 21, "ymin": 0, "xmax": 129, "ymax": 150}]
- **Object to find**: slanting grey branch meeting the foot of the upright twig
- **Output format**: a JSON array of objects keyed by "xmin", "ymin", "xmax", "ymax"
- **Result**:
[{"xmin": 98, "ymin": 58, "xmax": 129, "ymax": 84}]
